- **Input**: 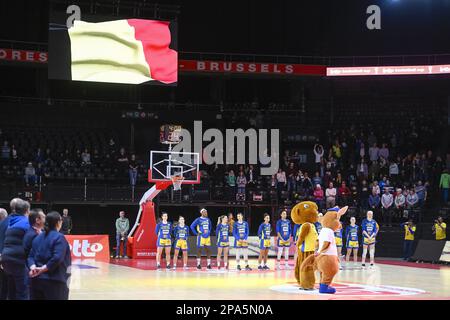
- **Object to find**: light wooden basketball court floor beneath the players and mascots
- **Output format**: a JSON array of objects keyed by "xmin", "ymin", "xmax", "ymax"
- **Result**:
[{"xmin": 70, "ymin": 260, "xmax": 450, "ymax": 300}]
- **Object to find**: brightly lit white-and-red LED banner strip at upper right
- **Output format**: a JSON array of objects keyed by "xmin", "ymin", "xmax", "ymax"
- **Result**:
[{"xmin": 327, "ymin": 64, "xmax": 450, "ymax": 77}]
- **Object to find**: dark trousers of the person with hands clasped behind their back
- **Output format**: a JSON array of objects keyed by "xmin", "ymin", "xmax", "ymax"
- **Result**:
[{"xmin": 31, "ymin": 278, "xmax": 69, "ymax": 300}]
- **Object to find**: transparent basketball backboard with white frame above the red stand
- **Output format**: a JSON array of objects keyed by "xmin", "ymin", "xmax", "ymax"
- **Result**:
[{"xmin": 148, "ymin": 151, "xmax": 200, "ymax": 184}]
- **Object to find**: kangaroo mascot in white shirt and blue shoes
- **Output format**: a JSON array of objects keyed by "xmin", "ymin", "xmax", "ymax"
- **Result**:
[{"xmin": 300, "ymin": 207, "xmax": 348, "ymax": 293}]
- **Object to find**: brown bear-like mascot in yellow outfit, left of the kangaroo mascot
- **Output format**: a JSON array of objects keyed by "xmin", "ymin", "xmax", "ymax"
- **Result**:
[{"xmin": 291, "ymin": 201, "xmax": 319, "ymax": 290}]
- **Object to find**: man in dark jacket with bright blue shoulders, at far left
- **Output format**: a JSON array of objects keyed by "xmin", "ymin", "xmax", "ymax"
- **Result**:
[{"xmin": 1, "ymin": 200, "xmax": 30, "ymax": 300}]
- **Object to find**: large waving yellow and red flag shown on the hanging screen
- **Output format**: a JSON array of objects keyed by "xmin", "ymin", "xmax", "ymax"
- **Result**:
[{"xmin": 69, "ymin": 19, "xmax": 178, "ymax": 84}]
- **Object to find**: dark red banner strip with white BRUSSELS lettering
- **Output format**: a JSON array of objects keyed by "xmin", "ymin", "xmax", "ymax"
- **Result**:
[{"xmin": 178, "ymin": 60, "xmax": 326, "ymax": 76}]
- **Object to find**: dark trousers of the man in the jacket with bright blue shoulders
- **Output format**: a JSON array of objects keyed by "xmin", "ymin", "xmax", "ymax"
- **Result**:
[{"xmin": 2, "ymin": 262, "xmax": 30, "ymax": 300}]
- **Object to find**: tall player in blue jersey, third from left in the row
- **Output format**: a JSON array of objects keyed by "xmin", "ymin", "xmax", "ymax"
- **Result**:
[{"xmin": 191, "ymin": 209, "xmax": 212, "ymax": 270}]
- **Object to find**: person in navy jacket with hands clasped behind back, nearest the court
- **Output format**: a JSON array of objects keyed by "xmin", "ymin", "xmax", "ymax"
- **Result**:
[{"xmin": 27, "ymin": 211, "xmax": 72, "ymax": 300}]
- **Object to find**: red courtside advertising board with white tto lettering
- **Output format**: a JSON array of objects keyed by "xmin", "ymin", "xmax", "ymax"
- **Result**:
[{"xmin": 66, "ymin": 235, "xmax": 110, "ymax": 261}]
